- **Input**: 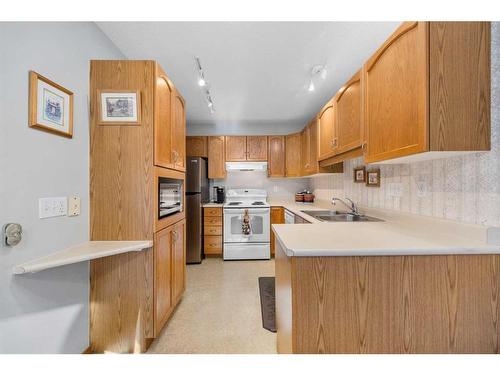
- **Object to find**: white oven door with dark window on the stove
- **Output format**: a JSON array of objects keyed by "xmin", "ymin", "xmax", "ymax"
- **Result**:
[{"xmin": 224, "ymin": 208, "xmax": 271, "ymax": 243}]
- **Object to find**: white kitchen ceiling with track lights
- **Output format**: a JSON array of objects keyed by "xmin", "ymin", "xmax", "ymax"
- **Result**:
[{"xmin": 97, "ymin": 22, "xmax": 399, "ymax": 133}]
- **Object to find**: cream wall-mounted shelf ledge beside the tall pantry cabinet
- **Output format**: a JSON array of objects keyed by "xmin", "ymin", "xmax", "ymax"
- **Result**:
[{"xmin": 12, "ymin": 241, "xmax": 153, "ymax": 275}]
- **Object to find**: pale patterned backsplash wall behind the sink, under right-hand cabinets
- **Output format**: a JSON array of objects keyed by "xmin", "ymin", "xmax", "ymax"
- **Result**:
[{"xmin": 311, "ymin": 22, "xmax": 500, "ymax": 226}]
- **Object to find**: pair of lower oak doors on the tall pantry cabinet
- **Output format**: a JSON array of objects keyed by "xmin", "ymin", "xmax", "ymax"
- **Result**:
[{"xmin": 153, "ymin": 219, "xmax": 186, "ymax": 337}]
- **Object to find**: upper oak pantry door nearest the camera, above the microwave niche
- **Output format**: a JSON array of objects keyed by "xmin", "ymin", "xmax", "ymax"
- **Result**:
[{"xmin": 154, "ymin": 69, "xmax": 173, "ymax": 168}]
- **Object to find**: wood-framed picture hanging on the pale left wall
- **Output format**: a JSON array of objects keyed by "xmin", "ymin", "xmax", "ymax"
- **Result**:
[{"xmin": 28, "ymin": 71, "xmax": 73, "ymax": 138}]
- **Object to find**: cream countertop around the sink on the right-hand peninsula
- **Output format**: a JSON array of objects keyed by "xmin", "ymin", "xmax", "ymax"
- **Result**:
[{"xmin": 269, "ymin": 199, "xmax": 500, "ymax": 256}]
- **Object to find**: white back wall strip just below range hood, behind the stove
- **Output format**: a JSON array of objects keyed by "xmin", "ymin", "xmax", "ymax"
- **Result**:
[{"xmin": 210, "ymin": 171, "xmax": 309, "ymax": 199}]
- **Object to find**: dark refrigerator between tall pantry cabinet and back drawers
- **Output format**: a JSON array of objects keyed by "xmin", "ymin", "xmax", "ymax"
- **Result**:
[{"xmin": 186, "ymin": 156, "xmax": 210, "ymax": 264}]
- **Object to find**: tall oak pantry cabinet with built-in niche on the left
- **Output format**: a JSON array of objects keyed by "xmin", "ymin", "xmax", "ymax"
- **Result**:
[{"xmin": 90, "ymin": 60, "xmax": 186, "ymax": 353}]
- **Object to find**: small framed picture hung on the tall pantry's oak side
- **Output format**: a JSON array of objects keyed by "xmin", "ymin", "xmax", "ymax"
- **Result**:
[{"xmin": 98, "ymin": 90, "xmax": 141, "ymax": 125}]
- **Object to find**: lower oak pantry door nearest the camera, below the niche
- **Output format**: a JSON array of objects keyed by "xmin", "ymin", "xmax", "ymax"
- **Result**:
[{"xmin": 153, "ymin": 227, "xmax": 172, "ymax": 335}]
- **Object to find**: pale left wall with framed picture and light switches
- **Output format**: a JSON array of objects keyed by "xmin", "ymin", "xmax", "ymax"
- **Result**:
[{"xmin": 0, "ymin": 23, "xmax": 123, "ymax": 353}]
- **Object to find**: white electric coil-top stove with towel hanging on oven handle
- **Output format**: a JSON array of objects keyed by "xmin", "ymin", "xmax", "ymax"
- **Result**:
[{"xmin": 224, "ymin": 189, "xmax": 271, "ymax": 260}]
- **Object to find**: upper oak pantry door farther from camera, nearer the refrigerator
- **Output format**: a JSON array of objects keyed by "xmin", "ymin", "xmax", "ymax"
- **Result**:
[{"xmin": 172, "ymin": 90, "xmax": 186, "ymax": 171}]
